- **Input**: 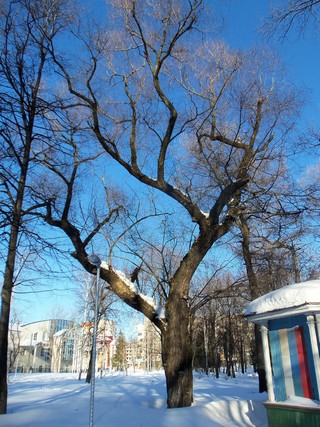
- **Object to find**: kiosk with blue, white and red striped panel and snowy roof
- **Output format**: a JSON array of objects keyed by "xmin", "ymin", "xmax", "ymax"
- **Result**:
[{"xmin": 245, "ymin": 280, "xmax": 320, "ymax": 427}]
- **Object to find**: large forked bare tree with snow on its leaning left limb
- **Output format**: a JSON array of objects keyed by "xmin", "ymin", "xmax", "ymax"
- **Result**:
[{"xmin": 37, "ymin": 0, "xmax": 296, "ymax": 408}]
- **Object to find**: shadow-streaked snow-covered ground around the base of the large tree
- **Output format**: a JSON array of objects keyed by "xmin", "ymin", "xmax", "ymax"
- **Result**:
[{"xmin": 0, "ymin": 372, "xmax": 267, "ymax": 427}]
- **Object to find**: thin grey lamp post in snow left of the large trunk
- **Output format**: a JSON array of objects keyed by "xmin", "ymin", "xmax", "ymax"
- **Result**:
[{"xmin": 88, "ymin": 255, "xmax": 101, "ymax": 427}]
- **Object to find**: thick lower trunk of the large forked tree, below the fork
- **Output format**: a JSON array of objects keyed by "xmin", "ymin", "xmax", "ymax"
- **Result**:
[{"xmin": 162, "ymin": 296, "xmax": 193, "ymax": 408}]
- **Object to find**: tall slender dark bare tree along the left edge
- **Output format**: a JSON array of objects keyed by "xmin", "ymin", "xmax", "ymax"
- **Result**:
[{"xmin": 0, "ymin": 0, "xmax": 72, "ymax": 414}]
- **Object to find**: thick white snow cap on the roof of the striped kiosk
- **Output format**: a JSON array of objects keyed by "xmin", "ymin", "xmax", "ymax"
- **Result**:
[{"xmin": 245, "ymin": 280, "xmax": 320, "ymax": 316}]
